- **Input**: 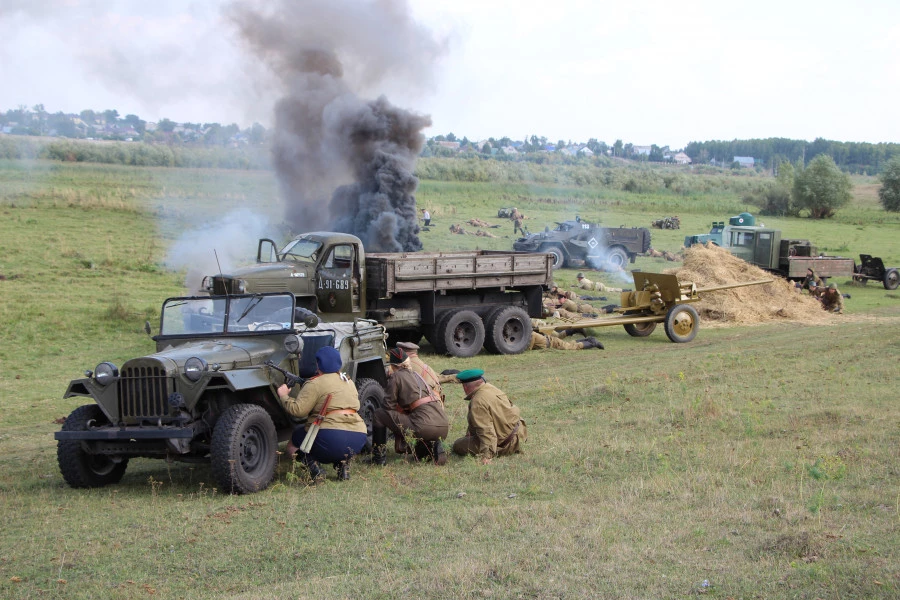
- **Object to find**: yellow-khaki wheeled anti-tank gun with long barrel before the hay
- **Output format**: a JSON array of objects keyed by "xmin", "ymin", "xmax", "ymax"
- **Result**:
[{"xmin": 537, "ymin": 271, "xmax": 772, "ymax": 343}]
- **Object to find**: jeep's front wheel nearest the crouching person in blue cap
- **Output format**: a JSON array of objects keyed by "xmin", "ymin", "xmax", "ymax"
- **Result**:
[{"xmin": 210, "ymin": 404, "xmax": 278, "ymax": 494}]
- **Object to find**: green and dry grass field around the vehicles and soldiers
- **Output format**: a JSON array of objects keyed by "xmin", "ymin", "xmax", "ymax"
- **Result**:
[{"xmin": 0, "ymin": 163, "xmax": 900, "ymax": 599}]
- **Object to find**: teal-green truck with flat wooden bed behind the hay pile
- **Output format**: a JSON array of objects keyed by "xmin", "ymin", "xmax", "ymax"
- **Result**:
[{"xmin": 684, "ymin": 213, "xmax": 856, "ymax": 280}]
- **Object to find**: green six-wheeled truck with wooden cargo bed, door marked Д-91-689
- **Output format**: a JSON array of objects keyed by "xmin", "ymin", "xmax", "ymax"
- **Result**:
[{"xmin": 201, "ymin": 232, "xmax": 553, "ymax": 356}]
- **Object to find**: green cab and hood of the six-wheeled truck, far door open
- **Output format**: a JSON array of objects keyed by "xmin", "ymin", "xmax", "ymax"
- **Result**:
[{"xmin": 201, "ymin": 231, "xmax": 365, "ymax": 321}]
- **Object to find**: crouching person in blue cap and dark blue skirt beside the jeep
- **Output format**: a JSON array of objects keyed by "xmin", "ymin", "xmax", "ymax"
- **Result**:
[{"xmin": 278, "ymin": 346, "xmax": 367, "ymax": 481}]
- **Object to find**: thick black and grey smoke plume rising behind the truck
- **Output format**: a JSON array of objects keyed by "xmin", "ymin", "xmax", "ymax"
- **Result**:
[{"xmin": 229, "ymin": 0, "xmax": 443, "ymax": 252}]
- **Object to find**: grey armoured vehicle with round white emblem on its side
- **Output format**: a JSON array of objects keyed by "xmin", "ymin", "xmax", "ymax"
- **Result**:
[{"xmin": 513, "ymin": 218, "xmax": 650, "ymax": 269}]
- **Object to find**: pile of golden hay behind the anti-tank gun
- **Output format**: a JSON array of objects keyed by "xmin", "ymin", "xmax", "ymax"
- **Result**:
[{"xmin": 665, "ymin": 244, "xmax": 840, "ymax": 325}]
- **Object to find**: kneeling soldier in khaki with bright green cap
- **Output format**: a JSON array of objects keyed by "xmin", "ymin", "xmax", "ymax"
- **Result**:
[{"xmin": 453, "ymin": 369, "xmax": 528, "ymax": 464}]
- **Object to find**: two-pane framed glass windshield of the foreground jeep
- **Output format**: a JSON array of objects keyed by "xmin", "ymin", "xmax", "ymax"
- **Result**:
[{"xmin": 160, "ymin": 294, "xmax": 294, "ymax": 336}]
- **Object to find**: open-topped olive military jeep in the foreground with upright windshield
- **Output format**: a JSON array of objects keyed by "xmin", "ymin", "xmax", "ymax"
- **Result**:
[{"xmin": 55, "ymin": 293, "xmax": 386, "ymax": 494}]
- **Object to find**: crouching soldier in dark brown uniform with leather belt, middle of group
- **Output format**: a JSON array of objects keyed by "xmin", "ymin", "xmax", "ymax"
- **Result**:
[{"xmin": 372, "ymin": 348, "xmax": 450, "ymax": 465}]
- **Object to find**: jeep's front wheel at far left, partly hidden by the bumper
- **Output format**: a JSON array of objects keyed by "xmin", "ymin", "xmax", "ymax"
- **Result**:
[{"xmin": 56, "ymin": 404, "xmax": 128, "ymax": 488}]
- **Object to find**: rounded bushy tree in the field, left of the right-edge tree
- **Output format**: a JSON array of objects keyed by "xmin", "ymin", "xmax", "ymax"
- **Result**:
[{"xmin": 792, "ymin": 154, "xmax": 853, "ymax": 219}]
